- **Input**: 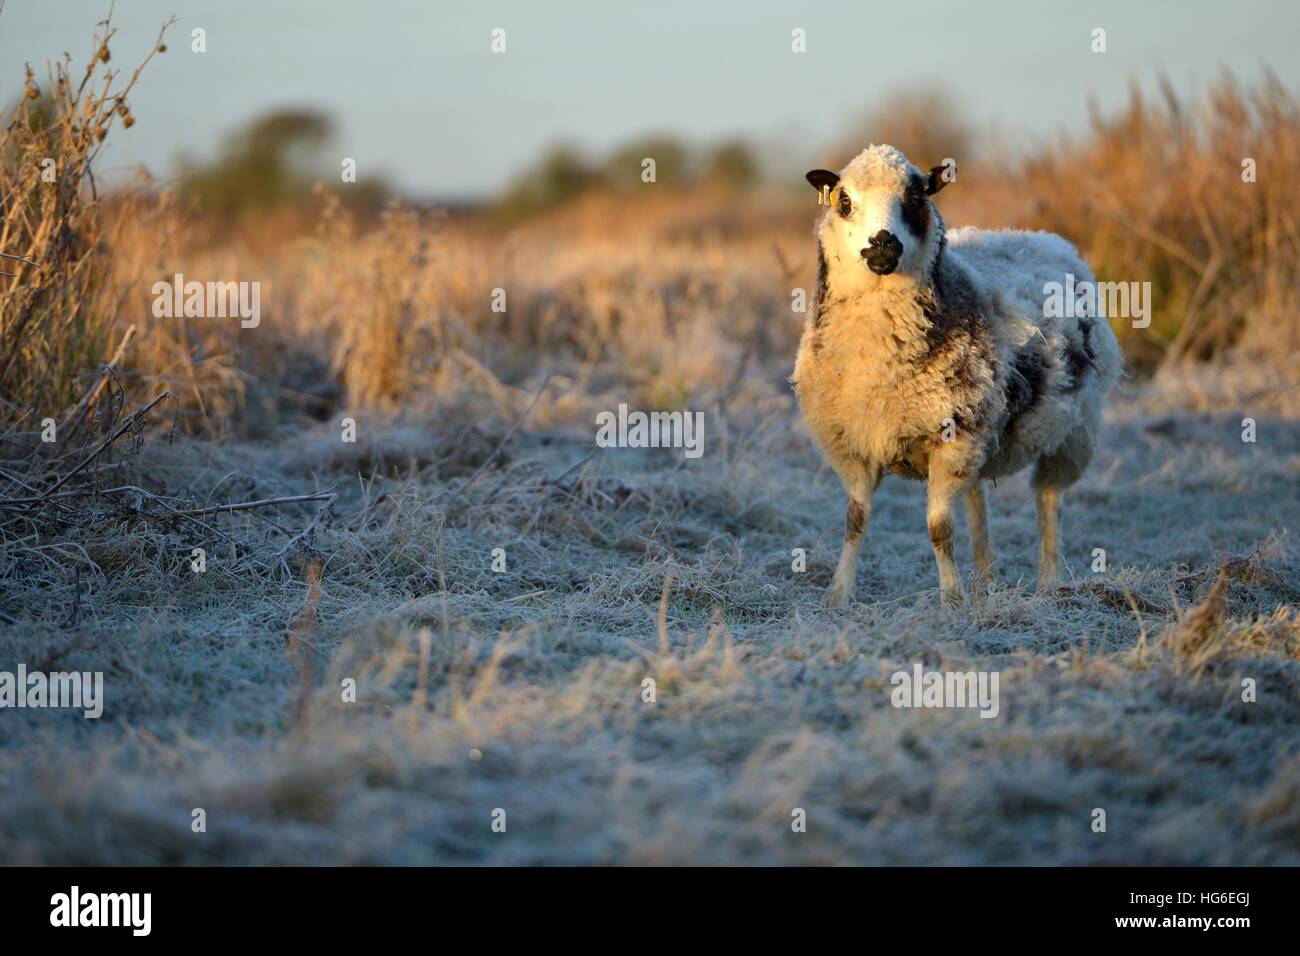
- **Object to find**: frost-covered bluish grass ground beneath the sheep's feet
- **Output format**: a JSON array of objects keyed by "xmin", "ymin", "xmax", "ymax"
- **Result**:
[{"xmin": 0, "ymin": 369, "xmax": 1300, "ymax": 865}]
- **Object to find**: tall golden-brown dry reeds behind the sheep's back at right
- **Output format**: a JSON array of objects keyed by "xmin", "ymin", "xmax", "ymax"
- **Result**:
[{"xmin": 1023, "ymin": 73, "xmax": 1300, "ymax": 367}]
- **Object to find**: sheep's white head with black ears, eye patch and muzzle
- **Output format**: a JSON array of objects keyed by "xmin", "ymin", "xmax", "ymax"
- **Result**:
[{"xmin": 807, "ymin": 146, "xmax": 946, "ymax": 285}]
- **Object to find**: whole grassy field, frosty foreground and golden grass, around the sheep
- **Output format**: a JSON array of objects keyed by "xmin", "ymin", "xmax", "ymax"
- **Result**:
[{"xmin": 0, "ymin": 16, "xmax": 1300, "ymax": 865}]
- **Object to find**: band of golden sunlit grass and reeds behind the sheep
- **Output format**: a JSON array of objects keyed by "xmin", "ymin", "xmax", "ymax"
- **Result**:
[{"xmin": 73, "ymin": 78, "xmax": 1300, "ymax": 431}]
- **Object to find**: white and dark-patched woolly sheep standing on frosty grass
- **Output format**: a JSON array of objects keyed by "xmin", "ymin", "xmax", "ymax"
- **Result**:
[{"xmin": 790, "ymin": 146, "xmax": 1123, "ymax": 607}]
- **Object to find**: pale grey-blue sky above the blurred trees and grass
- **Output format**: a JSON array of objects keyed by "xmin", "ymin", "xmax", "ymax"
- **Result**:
[{"xmin": 0, "ymin": 0, "xmax": 1300, "ymax": 198}]
